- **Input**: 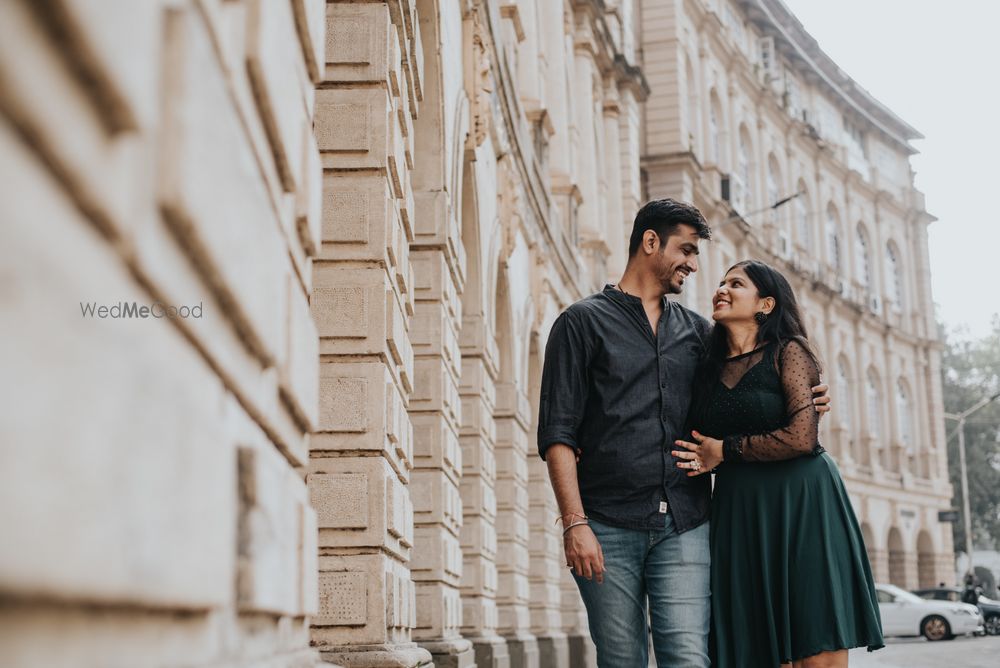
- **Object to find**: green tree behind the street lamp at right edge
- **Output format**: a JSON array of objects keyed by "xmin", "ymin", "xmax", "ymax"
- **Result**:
[{"xmin": 942, "ymin": 316, "xmax": 1000, "ymax": 549}]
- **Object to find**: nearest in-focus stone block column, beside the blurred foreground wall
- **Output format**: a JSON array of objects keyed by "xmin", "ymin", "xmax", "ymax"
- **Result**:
[{"xmin": 309, "ymin": 2, "xmax": 431, "ymax": 666}]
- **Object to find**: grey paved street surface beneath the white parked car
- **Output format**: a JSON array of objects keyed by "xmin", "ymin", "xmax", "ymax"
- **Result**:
[{"xmin": 850, "ymin": 636, "xmax": 1000, "ymax": 668}]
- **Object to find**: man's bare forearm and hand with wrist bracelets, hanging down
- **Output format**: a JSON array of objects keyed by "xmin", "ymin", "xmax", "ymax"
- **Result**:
[{"xmin": 545, "ymin": 443, "xmax": 604, "ymax": 583}]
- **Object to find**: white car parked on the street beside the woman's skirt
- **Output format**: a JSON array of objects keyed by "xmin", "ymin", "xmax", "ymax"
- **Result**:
[{"xmin": 875, "ymin": 584, "xmax": 983, "ymax": 640}]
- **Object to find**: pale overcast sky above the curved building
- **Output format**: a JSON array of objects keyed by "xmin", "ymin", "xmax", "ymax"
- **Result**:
[{"xmin": 784, "ymin": 0, "xmax": 1000, "ymax": 338}]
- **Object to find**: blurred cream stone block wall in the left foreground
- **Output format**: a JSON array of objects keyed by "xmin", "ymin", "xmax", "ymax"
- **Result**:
[{"xmin": 0, "ymin": 0, "xmax": 324, "ymax": 667}]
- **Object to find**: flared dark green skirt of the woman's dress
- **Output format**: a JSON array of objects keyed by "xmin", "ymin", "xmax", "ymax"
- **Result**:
[{"xmin": 711, "ymin": 453, "xmax": 884, "ymax": 668}]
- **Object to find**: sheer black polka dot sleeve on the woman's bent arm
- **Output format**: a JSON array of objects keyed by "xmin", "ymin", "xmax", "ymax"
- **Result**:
[{"xmin": 723, "ymin": 341, "xmax": 821, "ymax": 462}]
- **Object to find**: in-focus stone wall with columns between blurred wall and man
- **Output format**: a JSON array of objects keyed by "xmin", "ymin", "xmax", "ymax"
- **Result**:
[{"xmin": 300, "ymin": 0, "xmax": 647, "ymax": 667}]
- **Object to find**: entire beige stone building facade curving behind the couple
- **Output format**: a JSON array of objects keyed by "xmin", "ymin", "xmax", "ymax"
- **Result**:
[{"xmin": 0, "ymin": 0, "xmax": 952, "ymax": 668}]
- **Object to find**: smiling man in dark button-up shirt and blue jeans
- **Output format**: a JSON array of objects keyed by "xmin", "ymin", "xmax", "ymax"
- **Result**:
[{"xmin": 538, "ymin": 199, "xmax": 829, "ymax": 668}]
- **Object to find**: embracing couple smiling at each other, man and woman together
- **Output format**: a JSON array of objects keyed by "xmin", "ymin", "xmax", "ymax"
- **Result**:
[{"xmin": 538, "ymin": 199, "xmax": 882, "ymax": 668}]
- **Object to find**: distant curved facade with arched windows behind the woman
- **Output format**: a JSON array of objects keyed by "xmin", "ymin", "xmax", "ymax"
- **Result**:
[{"xmin": 641, "ymin": 0, "xmax": 954, "ymax": 588}]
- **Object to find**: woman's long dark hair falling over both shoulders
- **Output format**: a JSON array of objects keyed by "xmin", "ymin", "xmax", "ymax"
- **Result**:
[{"xmin": 696, "ymin": 260, "xmax": 820, "ymax": 394}]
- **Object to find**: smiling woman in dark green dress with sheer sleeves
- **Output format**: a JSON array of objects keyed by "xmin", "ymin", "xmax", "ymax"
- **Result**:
[{"xmin": 674, "ymin": 260, "xmax": 883, "ymax": 668}]
